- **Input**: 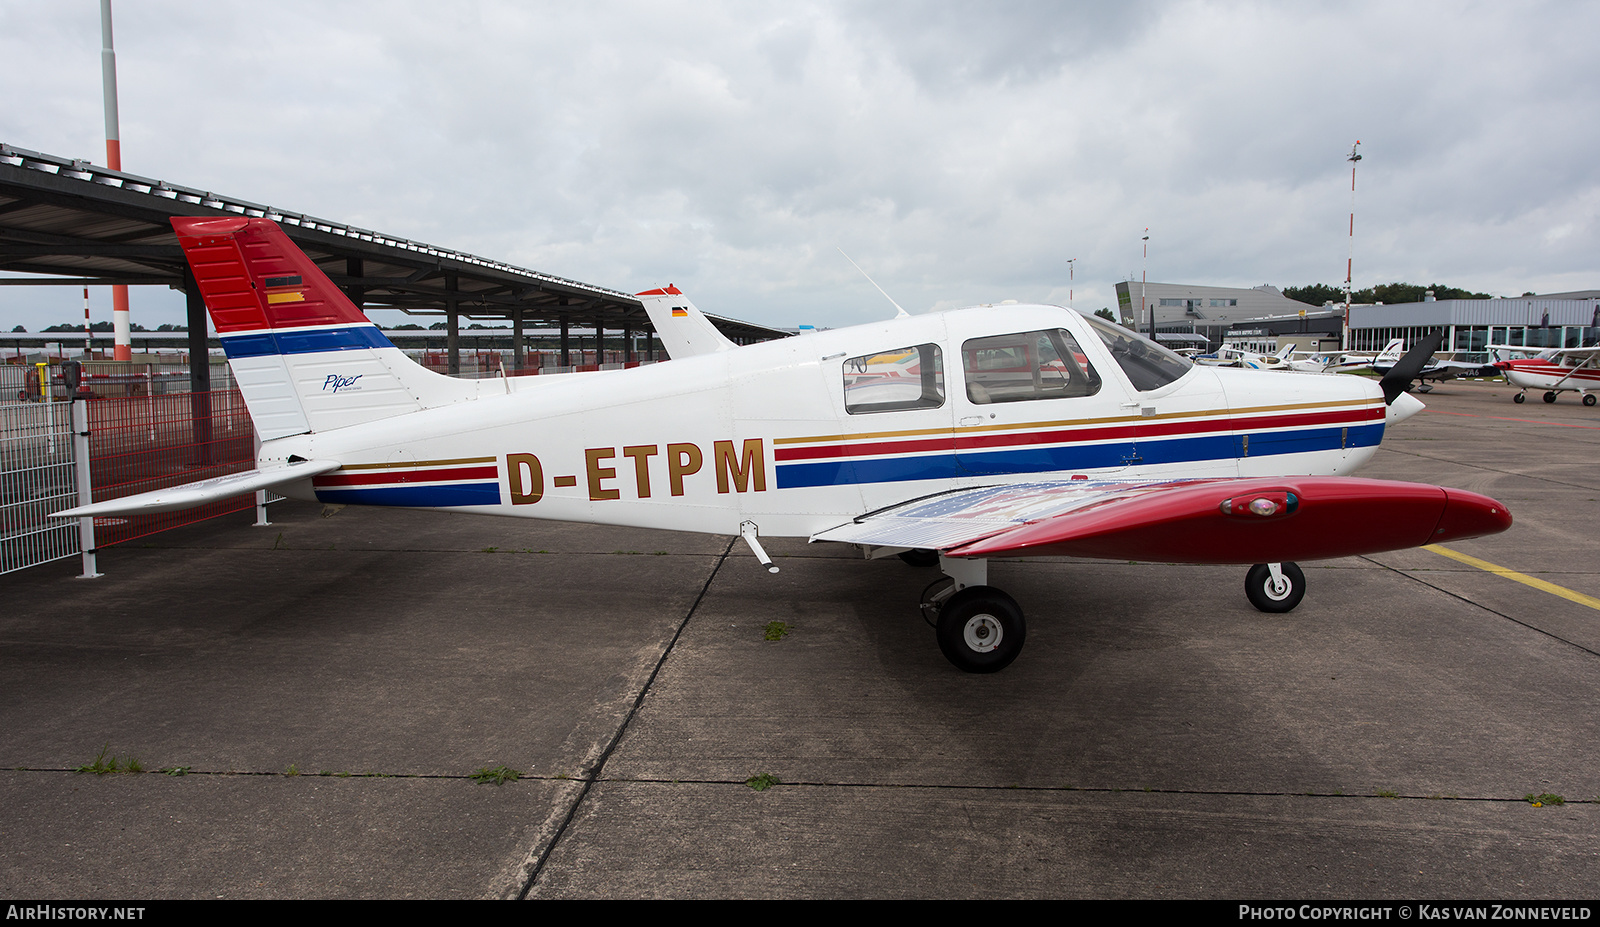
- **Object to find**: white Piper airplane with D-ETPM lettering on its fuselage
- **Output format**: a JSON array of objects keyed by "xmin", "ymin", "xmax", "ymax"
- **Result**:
[{"xmin": 59, "ymin": 218, "xmax": 1510, "ymax": 672}]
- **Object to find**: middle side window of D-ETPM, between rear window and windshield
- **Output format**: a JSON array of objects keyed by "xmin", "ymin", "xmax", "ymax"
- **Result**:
[{"xmin": 962, "ymin": 328, "xmax": 1101, "ymax": 405}]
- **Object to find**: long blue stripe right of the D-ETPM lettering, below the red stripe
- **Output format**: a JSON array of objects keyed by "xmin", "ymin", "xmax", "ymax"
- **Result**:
[{"xmin": 778, "ymin": 423, "xmax": 1384, "ymax": 490}]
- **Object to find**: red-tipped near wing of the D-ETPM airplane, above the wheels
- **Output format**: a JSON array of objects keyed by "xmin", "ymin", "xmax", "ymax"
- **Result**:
[{"xmin": 811, "ymin": 477, "xmax": 1510, "ymax": 564}]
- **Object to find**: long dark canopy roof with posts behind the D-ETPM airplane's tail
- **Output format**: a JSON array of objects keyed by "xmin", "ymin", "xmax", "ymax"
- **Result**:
[{"xmin": 0, "ymin": 142, "xmax": 790, "ymax": 381}]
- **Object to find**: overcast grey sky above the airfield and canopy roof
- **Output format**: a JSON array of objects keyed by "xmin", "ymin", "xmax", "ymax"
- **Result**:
[{"xmin": 0, "ymin": 0, "xmax": 1600, "ymax": 330}]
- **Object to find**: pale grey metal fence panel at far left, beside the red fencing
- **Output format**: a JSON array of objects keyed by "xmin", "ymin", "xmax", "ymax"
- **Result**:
[{"xmin": 0, "ymin": 402, "xmax": 78, "ymax": 573}]
